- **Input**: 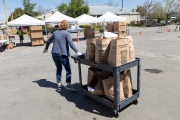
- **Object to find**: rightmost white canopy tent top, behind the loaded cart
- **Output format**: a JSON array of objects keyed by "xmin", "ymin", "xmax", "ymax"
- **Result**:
[{"xmin": 97, "ymin": 11, "xmax": 126, "ymax": 22}]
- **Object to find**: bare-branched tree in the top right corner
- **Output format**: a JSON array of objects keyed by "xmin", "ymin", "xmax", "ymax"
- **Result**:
[{"xmin": 164, "ymin": 0, "xmax": 180, "ymax": 22}]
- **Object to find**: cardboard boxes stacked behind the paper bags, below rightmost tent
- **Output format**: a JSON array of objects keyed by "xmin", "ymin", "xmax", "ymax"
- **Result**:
[{"xmin": 107, "ymin": 22, "xmax": 126, "ymax": 37}]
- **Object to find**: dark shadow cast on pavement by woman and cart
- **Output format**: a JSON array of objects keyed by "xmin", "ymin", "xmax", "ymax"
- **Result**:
[{"xmin": 33, "ymin": 79, "xmax": 114, "ymax": 118}]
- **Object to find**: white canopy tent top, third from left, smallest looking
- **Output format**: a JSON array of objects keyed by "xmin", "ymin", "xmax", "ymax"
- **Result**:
[{"xmin": 75, "ymin": 14, "xmax": 98, "ymax": 25}]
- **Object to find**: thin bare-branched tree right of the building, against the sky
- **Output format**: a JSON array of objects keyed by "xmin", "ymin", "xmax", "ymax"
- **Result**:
[{"xmin": 143, "ymin": 0, "xmax": 156, "ymax": 25}]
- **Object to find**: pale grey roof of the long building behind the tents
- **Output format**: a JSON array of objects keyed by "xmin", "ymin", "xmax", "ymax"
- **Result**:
[{"xmin": 89, "ymin": 5, "xmax": 139, "ymax": 15}]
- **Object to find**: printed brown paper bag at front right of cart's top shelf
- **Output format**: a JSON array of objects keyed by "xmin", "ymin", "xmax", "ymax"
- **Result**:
[{"xmin": 108, "ymin": 38, "xmax": 129, "ymax": 66}]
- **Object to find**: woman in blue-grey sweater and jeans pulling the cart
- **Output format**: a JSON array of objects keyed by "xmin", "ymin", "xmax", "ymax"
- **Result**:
[{"xmin": 43, "ymin": 20, "xmax": 82, "ymax": 91}]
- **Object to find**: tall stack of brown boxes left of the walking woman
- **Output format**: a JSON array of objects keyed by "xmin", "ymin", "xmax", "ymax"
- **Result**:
[{"xmin": 30, "ymin": 26, "xmax": 44, "ymax": 46}]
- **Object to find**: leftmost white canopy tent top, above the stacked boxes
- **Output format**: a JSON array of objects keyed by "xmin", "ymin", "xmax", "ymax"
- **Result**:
[{"xmin": 7, "ymin": 14, "xmax": 45, "ymax": 26}]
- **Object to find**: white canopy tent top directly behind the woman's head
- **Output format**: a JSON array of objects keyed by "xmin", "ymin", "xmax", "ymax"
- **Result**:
[{"xmin": 45, "ymin": 11, "xmax": 76, "ymax": 23}]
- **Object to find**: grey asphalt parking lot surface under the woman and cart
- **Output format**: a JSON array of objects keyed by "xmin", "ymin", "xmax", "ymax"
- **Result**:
[{"xmin": 0, "ymin": 26, "xmax": 180, "ymax": 120}]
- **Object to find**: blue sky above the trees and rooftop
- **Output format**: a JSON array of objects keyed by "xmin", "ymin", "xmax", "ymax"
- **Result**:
[{"xmin": 0, "ymin": 0, "xmax": 160, "ymax": 22}]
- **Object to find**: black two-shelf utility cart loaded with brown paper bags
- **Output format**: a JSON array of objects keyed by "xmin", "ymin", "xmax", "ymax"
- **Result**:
[{"xmin": 71, "ymin": 55, "xmax": 141, "ymax": 117}]
